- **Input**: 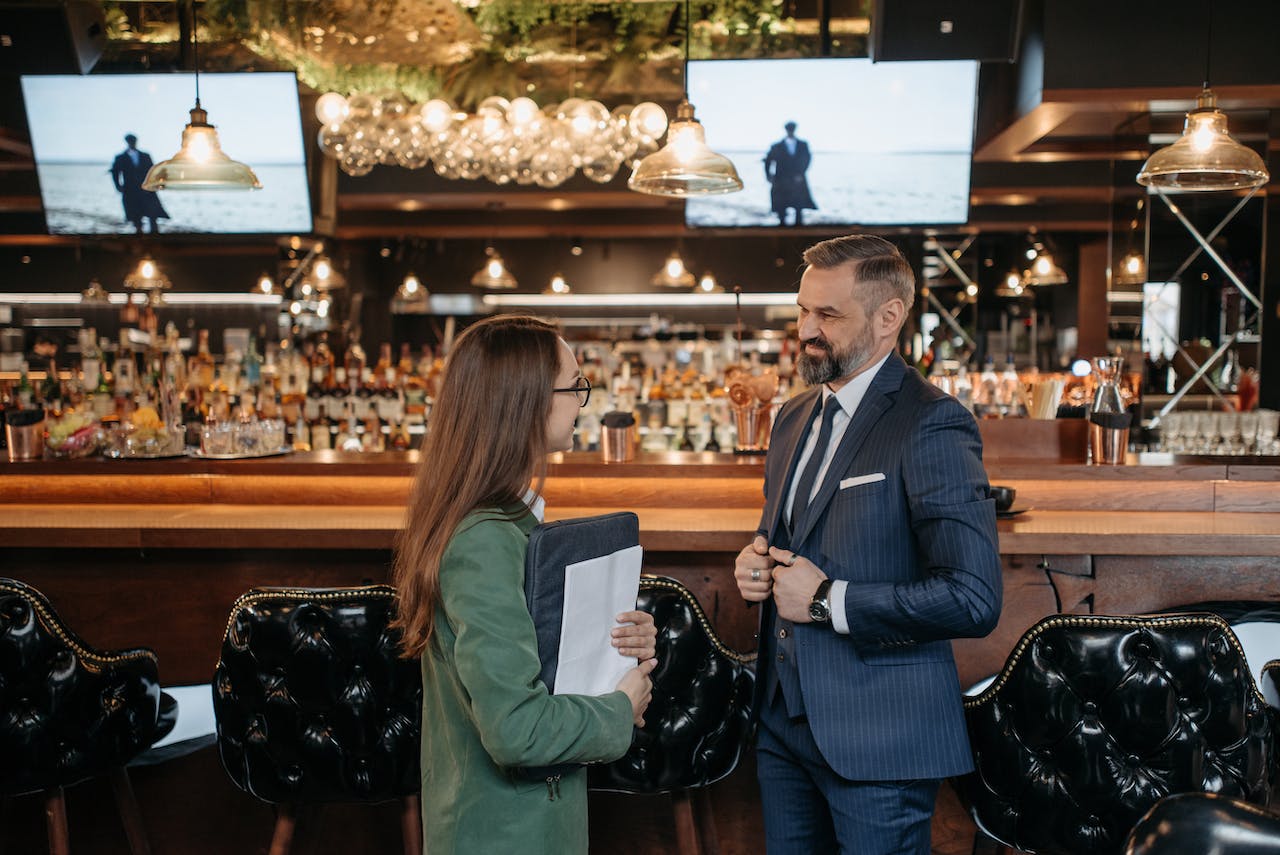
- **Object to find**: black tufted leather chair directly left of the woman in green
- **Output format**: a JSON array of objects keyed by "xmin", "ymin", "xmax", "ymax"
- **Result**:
[{"xmin": 214, "ymin": 585, "xmax": 422, "ymax": 855}]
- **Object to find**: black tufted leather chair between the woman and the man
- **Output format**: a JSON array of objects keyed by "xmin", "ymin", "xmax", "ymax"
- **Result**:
[{"xmin": 589, "ymin": 576, "xmax": 755, "ymax": 851}]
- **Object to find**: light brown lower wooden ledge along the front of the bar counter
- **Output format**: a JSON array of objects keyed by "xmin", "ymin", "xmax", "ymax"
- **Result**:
[{"xmin": 0, "ymin": 504, "xmax": 1280, "ymax": 557}]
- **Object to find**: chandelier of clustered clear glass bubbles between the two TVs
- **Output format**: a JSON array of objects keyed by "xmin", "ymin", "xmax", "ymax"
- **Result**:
[{"xmin": 316, "ymin": 92, "xmax": 667, "ymax": 187}]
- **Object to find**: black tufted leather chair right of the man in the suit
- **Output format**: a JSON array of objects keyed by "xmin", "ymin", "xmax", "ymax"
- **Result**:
[{"xmin": 960, "ymin": 614, "xmax": 1275, "ymax": 855}]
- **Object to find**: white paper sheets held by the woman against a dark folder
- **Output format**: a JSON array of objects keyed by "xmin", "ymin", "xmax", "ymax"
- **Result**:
[{"xmin": 552, "ymin": 547, "xmax": 644, "ymax": 695}]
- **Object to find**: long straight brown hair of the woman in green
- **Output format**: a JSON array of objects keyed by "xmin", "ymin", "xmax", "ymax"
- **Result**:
[{"xmin": 392, "ymin": 315, "xmax": 561, "ymax": 658}]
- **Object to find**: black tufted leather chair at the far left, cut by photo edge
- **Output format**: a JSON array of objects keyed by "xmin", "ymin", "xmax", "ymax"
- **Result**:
[{"xmin": 0, "ymin": 579, "xmax": 175, "ymax": 855}]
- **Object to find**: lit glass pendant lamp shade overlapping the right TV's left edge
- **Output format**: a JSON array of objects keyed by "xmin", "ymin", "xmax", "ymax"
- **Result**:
[{"xmin": 627, "ymin": 100, "xmax": 742, "ymax": 198}]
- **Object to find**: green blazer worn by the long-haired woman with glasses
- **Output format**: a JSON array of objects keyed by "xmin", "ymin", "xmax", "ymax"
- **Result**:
[{"xmin": 422, "ymin": 504, "xmax": 631, "ymax": 855}]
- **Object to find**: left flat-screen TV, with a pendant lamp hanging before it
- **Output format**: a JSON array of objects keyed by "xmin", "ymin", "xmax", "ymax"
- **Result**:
[{"xmin": 22, "ymin": 72, "xmax": 311, "ymax": 234}]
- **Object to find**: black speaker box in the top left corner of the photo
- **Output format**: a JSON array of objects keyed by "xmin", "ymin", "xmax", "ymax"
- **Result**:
[{"xmin": 0, "ymin": 0, "xmax": 106, "ymax": 74}]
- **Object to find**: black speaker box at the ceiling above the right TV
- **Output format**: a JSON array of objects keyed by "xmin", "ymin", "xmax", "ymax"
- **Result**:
[{"xmin": 870, "ymin": 0, "xmax": 1023, "ymax": 63}]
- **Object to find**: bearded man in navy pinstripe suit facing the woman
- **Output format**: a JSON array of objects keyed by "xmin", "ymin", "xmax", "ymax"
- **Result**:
[{"xmin": 735, "ymin": 236, "xmax": 1001, "ymax": 855}]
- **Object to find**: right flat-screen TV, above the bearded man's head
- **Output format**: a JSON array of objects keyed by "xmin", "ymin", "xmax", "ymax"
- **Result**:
[{"xmin": 685, "ymin": 59, "xmax": 978, "ymax": 228}]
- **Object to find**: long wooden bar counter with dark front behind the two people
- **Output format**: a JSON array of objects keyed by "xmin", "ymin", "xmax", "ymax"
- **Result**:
[{"xmin": 0, "ymin": 447, "xmax": 1280, "ymax": 854}]
